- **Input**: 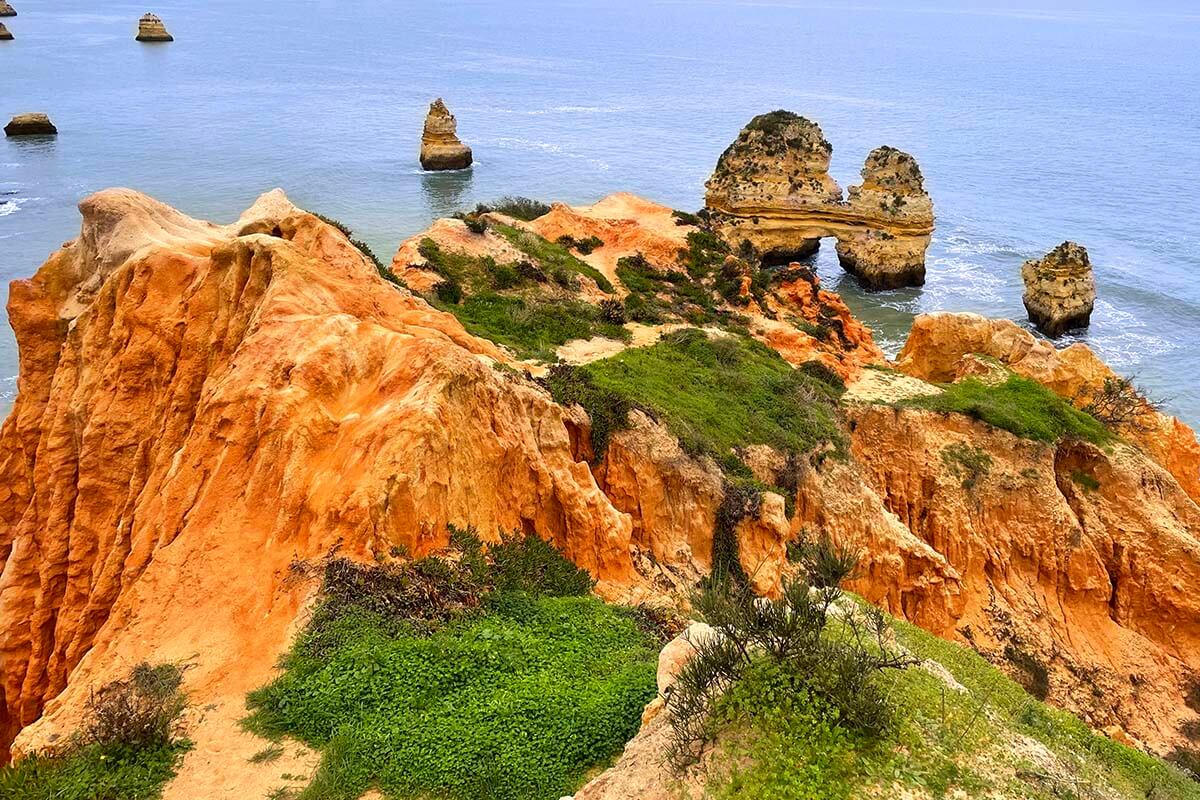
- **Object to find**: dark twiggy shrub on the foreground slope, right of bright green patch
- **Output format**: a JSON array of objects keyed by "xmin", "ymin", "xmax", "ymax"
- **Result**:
[{"xmin": 667, "ymin": 539, "xmax": 916, "ymax": 766}]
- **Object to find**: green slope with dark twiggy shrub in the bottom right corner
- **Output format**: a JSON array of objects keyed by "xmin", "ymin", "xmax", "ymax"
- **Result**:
[{"xmin": 686, "ymin": 541, "xmax": 1200, "ymax": 800}]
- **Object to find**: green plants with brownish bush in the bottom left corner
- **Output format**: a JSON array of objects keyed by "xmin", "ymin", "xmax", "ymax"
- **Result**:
[{"xmin": 0, "ymin": 663, "xmax": 191, "ymax": 800}]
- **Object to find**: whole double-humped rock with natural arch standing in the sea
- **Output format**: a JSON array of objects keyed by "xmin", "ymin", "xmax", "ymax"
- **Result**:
[{"xmin": 704, "ymin": 112, "xmax": 934, "ymax": 289}]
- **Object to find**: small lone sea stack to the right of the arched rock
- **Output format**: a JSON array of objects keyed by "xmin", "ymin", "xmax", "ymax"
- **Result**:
[{"xmin": 1021, "ymin": 241, "xmax": 1096, "ymax": 336}]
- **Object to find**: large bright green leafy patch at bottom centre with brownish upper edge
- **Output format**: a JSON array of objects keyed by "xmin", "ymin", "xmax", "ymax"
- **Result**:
[{"xmin": 247, "ymin": 531, "xmax": 659, "ymax": 800}]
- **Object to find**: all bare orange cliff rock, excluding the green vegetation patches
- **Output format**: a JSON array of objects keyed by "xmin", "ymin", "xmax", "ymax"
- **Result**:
[{"xmin": 0, "ymin": 190, "xmax": 1200, "ymax": 777}]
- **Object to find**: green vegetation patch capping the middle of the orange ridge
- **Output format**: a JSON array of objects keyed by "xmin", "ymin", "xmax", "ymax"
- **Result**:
[{"xmin": 580, "ymin": 329, "xmax": 845, "ymax": 479}]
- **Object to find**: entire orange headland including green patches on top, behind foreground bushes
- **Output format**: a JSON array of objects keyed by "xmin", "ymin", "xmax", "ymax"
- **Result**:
[{"xmin": 0, "ymin": 189, "xmax": 1200, "ymax": 798}]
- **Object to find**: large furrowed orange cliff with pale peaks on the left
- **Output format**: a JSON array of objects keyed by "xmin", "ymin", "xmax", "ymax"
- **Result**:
[{"xmin": 0, "ymin": 190, "xmax": 638, "ymax": 751}]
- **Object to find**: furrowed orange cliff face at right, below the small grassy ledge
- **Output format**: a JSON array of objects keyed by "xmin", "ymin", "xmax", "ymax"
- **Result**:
[{"xmin": 840, "ymin": 404, "xmax": 1200, "ymax": 752}]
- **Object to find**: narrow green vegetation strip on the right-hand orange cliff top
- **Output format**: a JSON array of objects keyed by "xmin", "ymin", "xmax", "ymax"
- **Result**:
[{"xmin": 899, "ymin": 375, "xmax": 1114, "ymax": 445}]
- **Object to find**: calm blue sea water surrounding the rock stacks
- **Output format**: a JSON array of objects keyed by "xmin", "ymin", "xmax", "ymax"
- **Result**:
[{"xmin": 0, "ymin": 0, "xmax": 1200, "ymax": 423}]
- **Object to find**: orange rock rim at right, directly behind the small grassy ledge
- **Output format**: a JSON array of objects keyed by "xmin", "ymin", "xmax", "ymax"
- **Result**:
[{"xmin": 896, "ymin": 313, "xmax": 1200, "ymax": 503}]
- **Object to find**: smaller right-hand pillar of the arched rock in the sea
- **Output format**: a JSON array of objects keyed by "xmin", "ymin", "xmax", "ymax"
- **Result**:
[{"xmin": 838, "ymin": 146, "xmax": 934, "ymax": 289}]
